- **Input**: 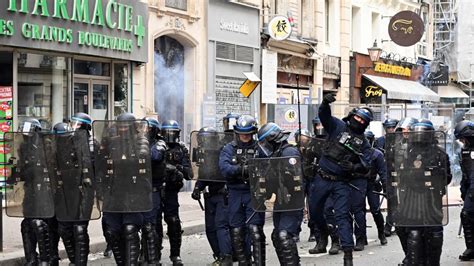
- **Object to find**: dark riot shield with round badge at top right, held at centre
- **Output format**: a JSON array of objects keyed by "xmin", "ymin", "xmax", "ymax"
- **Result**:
[{"xmin": 248, "ymin": 157, "xmax": 304, "ymax": 212}]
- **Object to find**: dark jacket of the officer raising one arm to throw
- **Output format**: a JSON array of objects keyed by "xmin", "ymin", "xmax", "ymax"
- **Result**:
[{"xmin": 319, "ymin": 103, "xmax": 370, "ymax": 178}]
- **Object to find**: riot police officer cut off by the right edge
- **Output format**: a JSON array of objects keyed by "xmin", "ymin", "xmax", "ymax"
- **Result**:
[{"xmin": 454, "ymin": 121, "xmax": 474, "ymax": 261}]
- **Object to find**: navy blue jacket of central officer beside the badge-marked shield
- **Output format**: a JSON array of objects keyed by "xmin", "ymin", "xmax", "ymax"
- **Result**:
[{"xmin": 219, "ymin": 140, "xmax": 257, "ymax": 190}]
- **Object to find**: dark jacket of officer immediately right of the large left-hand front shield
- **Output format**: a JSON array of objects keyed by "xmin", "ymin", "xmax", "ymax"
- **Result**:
[{"xmin": 150, "ymin": 139, "xmax": 168, "ymax": 188}]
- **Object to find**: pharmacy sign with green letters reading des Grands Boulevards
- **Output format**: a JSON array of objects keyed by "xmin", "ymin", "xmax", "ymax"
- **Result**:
[{"xmin": 0, "ymin": 0, "xmax": 148, "ymax": 62}]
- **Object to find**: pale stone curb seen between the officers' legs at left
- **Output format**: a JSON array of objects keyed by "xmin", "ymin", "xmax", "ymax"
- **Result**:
[{"xmin": 0, "ymin": 221, "xmax": 205, "ymax": 266}]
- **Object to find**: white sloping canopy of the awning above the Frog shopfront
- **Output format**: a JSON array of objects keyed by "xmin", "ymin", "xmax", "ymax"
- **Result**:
[{"xmin": 363, "ymin": 74, "xmax": 440, "ymax": 102}]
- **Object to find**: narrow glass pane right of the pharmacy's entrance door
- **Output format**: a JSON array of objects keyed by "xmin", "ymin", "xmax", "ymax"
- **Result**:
[{"xmin": 114, "ymin": 64, "xmax": 129, "ymax": 116}]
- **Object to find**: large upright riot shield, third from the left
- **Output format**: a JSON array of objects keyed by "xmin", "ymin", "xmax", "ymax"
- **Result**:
[{"xmin": 92, "ymin": 120, "xmax": 153, "ymax": 213}]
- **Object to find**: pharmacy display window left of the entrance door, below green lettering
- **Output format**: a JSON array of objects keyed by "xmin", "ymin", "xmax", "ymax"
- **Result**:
[{"xmin": 17, "ymin": 53, "xmax": 69, "ymax": 127}]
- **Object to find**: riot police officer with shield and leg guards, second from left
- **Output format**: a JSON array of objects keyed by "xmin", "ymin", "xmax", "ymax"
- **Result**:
[{"xmin": 52, "ymin": 116, "xmax": 98, "ymax": 265}]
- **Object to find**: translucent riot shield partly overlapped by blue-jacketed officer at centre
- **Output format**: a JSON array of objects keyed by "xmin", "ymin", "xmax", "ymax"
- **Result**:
[{"xmin": 191, "ymin": 131, "xmax": 234, "ymax": 182}]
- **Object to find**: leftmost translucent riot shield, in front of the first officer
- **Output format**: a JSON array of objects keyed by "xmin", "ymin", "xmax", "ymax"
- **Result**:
[{"xmin": 2, "ymin": 132, "xmax": 55, "ymax": 218}]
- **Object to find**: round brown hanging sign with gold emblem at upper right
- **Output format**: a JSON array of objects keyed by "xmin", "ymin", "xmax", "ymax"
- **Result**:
[{"xmin": 388, "ymin": 10, "xmax": 425, "ymax": 46}]
